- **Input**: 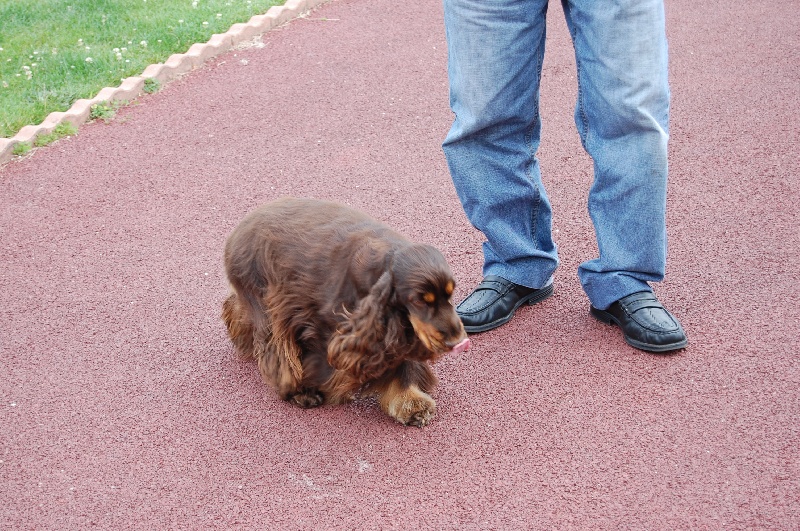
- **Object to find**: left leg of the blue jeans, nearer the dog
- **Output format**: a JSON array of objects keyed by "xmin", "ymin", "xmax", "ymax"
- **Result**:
[{"xmin": 442, "ymin": 0, "xmax": 558, "ymax": 288}]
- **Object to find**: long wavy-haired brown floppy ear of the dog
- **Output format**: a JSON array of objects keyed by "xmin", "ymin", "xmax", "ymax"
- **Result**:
[{"xmin": 328, "ymin": 271, "xmax": 393, "ymax": 383}]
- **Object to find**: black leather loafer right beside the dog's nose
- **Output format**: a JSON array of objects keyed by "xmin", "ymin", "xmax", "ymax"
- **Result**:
[{"xmin": 456, "ymin": 275, "xmax": 553, "ymax": 334}]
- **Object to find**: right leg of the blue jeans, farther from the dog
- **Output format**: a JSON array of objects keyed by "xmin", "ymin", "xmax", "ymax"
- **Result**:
[{"xmin": 562, "ymin": 0, "xmax": 669, "ymax": 309}]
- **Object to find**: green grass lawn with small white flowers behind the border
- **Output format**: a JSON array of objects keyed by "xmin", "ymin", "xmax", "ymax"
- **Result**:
[{"xmin": 0, "ymin": 0, "xmax": 285, "ymax": 138}]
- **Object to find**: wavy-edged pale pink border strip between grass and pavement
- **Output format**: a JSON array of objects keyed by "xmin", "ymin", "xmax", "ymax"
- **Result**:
[{"xmin": 0, "ymin": 0, "xmax": 329, "ymax": 164}]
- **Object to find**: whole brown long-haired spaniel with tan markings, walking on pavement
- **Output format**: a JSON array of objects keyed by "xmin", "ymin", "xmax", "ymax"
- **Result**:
[{"xmin": 222, "ymin": 198, "xmax": 467, "ymax": 426}]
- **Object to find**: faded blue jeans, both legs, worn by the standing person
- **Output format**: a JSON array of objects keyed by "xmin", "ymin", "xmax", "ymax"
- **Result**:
[{"xmin": 442, "ymin": 0, "xmax": 669, "ymax": 309}]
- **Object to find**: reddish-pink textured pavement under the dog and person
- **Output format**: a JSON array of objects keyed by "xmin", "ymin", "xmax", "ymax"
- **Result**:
[{"xmin": 0, "ymin": 0, "xmax": 800, "ymax": 529}]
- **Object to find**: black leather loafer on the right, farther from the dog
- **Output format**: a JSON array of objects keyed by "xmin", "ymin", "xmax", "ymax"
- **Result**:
[{"xmin": 589, "ymin": 291, "xmax": 687, "ymax": 352}]
